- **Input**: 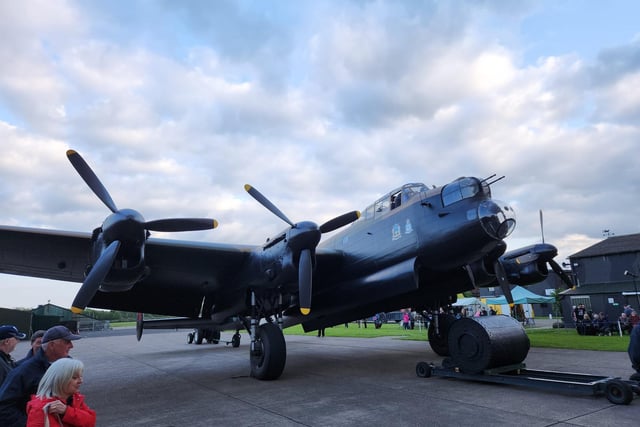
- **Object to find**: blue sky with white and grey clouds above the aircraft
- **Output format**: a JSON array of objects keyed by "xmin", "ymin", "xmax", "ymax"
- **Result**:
[{"xmin": 0, "ymin": 0, "xmax": 640, "ymax": 307}]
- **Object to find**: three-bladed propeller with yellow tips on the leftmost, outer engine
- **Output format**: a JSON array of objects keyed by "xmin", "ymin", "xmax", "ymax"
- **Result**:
[{"xmin": 67, "ymin": 150, "xmax": 218, "ymax": 313}]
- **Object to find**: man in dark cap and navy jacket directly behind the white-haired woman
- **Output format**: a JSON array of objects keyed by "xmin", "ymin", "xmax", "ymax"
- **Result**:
[{"xmin": 0, "ymin": 326, "xmax": 80, "ymax": 427}]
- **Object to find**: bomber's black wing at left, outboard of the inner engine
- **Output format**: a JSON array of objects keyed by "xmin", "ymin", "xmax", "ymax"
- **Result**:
[{"xmin": 0, "ymin": 226, "xmax": 254, "ymax": 317}]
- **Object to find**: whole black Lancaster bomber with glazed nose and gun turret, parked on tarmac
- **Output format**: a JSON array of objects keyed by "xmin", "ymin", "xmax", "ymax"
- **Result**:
[{"xmin": 0, "ymin": 150, "xmax": 570, "ymax": 380}]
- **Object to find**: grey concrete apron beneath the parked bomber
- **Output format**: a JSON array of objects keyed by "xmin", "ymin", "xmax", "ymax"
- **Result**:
[{"xmin": 13, "ymin": 328, "xmax": 640, "ymax": 427}]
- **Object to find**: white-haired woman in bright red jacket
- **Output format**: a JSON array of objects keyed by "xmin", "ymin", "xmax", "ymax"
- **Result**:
[{"xmin": 27, "ymin": 358, "xmax": 96, "ymax": 427}]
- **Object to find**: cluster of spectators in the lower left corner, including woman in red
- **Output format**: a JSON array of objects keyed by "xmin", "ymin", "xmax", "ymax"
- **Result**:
[{"xmin": 0, "ymin": 325, "xmax": 96, "ymax": 427}]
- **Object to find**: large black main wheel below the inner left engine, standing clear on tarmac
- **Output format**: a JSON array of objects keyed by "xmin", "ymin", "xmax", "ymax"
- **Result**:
[{"xmin": 250, "ymin": 323, "xmax": 287, "ymax": 380}]
